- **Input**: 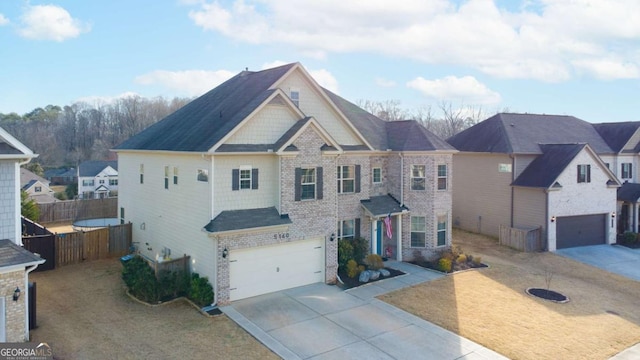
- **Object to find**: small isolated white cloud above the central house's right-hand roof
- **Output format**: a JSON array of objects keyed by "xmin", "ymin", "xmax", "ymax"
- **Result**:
[{"xmin": 407, "ymin": 76, "xmax": 502, "ymax": 105}]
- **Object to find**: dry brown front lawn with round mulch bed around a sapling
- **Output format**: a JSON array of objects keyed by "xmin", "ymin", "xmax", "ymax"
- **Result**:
[{"xmin": 380, "ymin": 231, "xmax": 640, "ymax": 359}]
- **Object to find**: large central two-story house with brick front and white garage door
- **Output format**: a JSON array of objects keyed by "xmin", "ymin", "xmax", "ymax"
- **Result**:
[{"xmin": 115, "ymin": 63, "xmax": 455, "ymax": 304}]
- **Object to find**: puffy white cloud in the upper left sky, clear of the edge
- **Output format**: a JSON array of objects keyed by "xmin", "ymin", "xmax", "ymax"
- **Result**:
[{"xmin": 18, "ymin": 5, "xmax": 90, "ymax": 41}]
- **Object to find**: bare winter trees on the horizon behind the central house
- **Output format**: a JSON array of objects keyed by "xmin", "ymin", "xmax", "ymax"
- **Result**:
[{"xmin": 0, "ymin": 95, "xmax": 485, "ymax": 173}]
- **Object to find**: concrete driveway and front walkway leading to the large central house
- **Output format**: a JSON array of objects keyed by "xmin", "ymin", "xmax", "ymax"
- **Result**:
[{"xmin": 221, "ymin": 262, "xmax": 506, "ymax": 360}]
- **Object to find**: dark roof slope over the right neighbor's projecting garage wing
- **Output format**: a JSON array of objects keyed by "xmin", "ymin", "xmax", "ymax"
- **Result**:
[{"xmin": 512, "ymin": 144, "xmax": 586, "ymax": 189}]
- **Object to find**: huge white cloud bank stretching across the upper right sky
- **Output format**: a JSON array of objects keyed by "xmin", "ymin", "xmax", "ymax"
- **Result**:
[{"xmin": 189, "ymin": 0, "xmax": 640, "ymax": 82}]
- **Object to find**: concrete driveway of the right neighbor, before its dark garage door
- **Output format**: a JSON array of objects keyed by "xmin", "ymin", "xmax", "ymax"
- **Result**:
[{"xmin": 556, "ymin": 245, "xmax": 640, "ymax": 281}]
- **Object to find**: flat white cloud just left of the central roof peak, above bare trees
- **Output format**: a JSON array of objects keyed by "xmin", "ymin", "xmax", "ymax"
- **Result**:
[{"xmin": 135, "ymin": 70, "xmax": 235, "ymax": 96}]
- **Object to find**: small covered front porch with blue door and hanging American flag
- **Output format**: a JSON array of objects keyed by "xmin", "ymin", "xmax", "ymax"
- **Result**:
[{"xmin": 360, "ymin": 195, "xmax": 409, "ymax": 261}]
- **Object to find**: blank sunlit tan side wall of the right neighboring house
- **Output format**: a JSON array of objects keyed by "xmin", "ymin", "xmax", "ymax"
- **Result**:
[{"xmin": 453, "ymin": 153, "xmax": 512, "ymax": 237}]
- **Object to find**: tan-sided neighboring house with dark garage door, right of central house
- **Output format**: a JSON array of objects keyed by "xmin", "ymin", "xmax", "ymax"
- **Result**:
[{"xmin": 447, "ymin": 114, "xmax": 620, "ymax": 251}]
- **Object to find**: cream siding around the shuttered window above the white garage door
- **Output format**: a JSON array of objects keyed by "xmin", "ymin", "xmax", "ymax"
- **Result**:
[{"xmin": 211, "ymin": 155, "xmax": 280, "ymax": 217}]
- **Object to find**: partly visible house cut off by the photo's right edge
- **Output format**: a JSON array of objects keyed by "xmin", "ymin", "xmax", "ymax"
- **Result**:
[{"xmin": 593, "ymin": 121, "xmax": 640, "ymax": 233}]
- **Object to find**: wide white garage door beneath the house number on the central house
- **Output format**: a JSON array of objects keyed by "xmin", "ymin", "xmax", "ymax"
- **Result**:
[{"xmin": 229, "ymin": 238, "xmax": 324, "ymax": 301}]
